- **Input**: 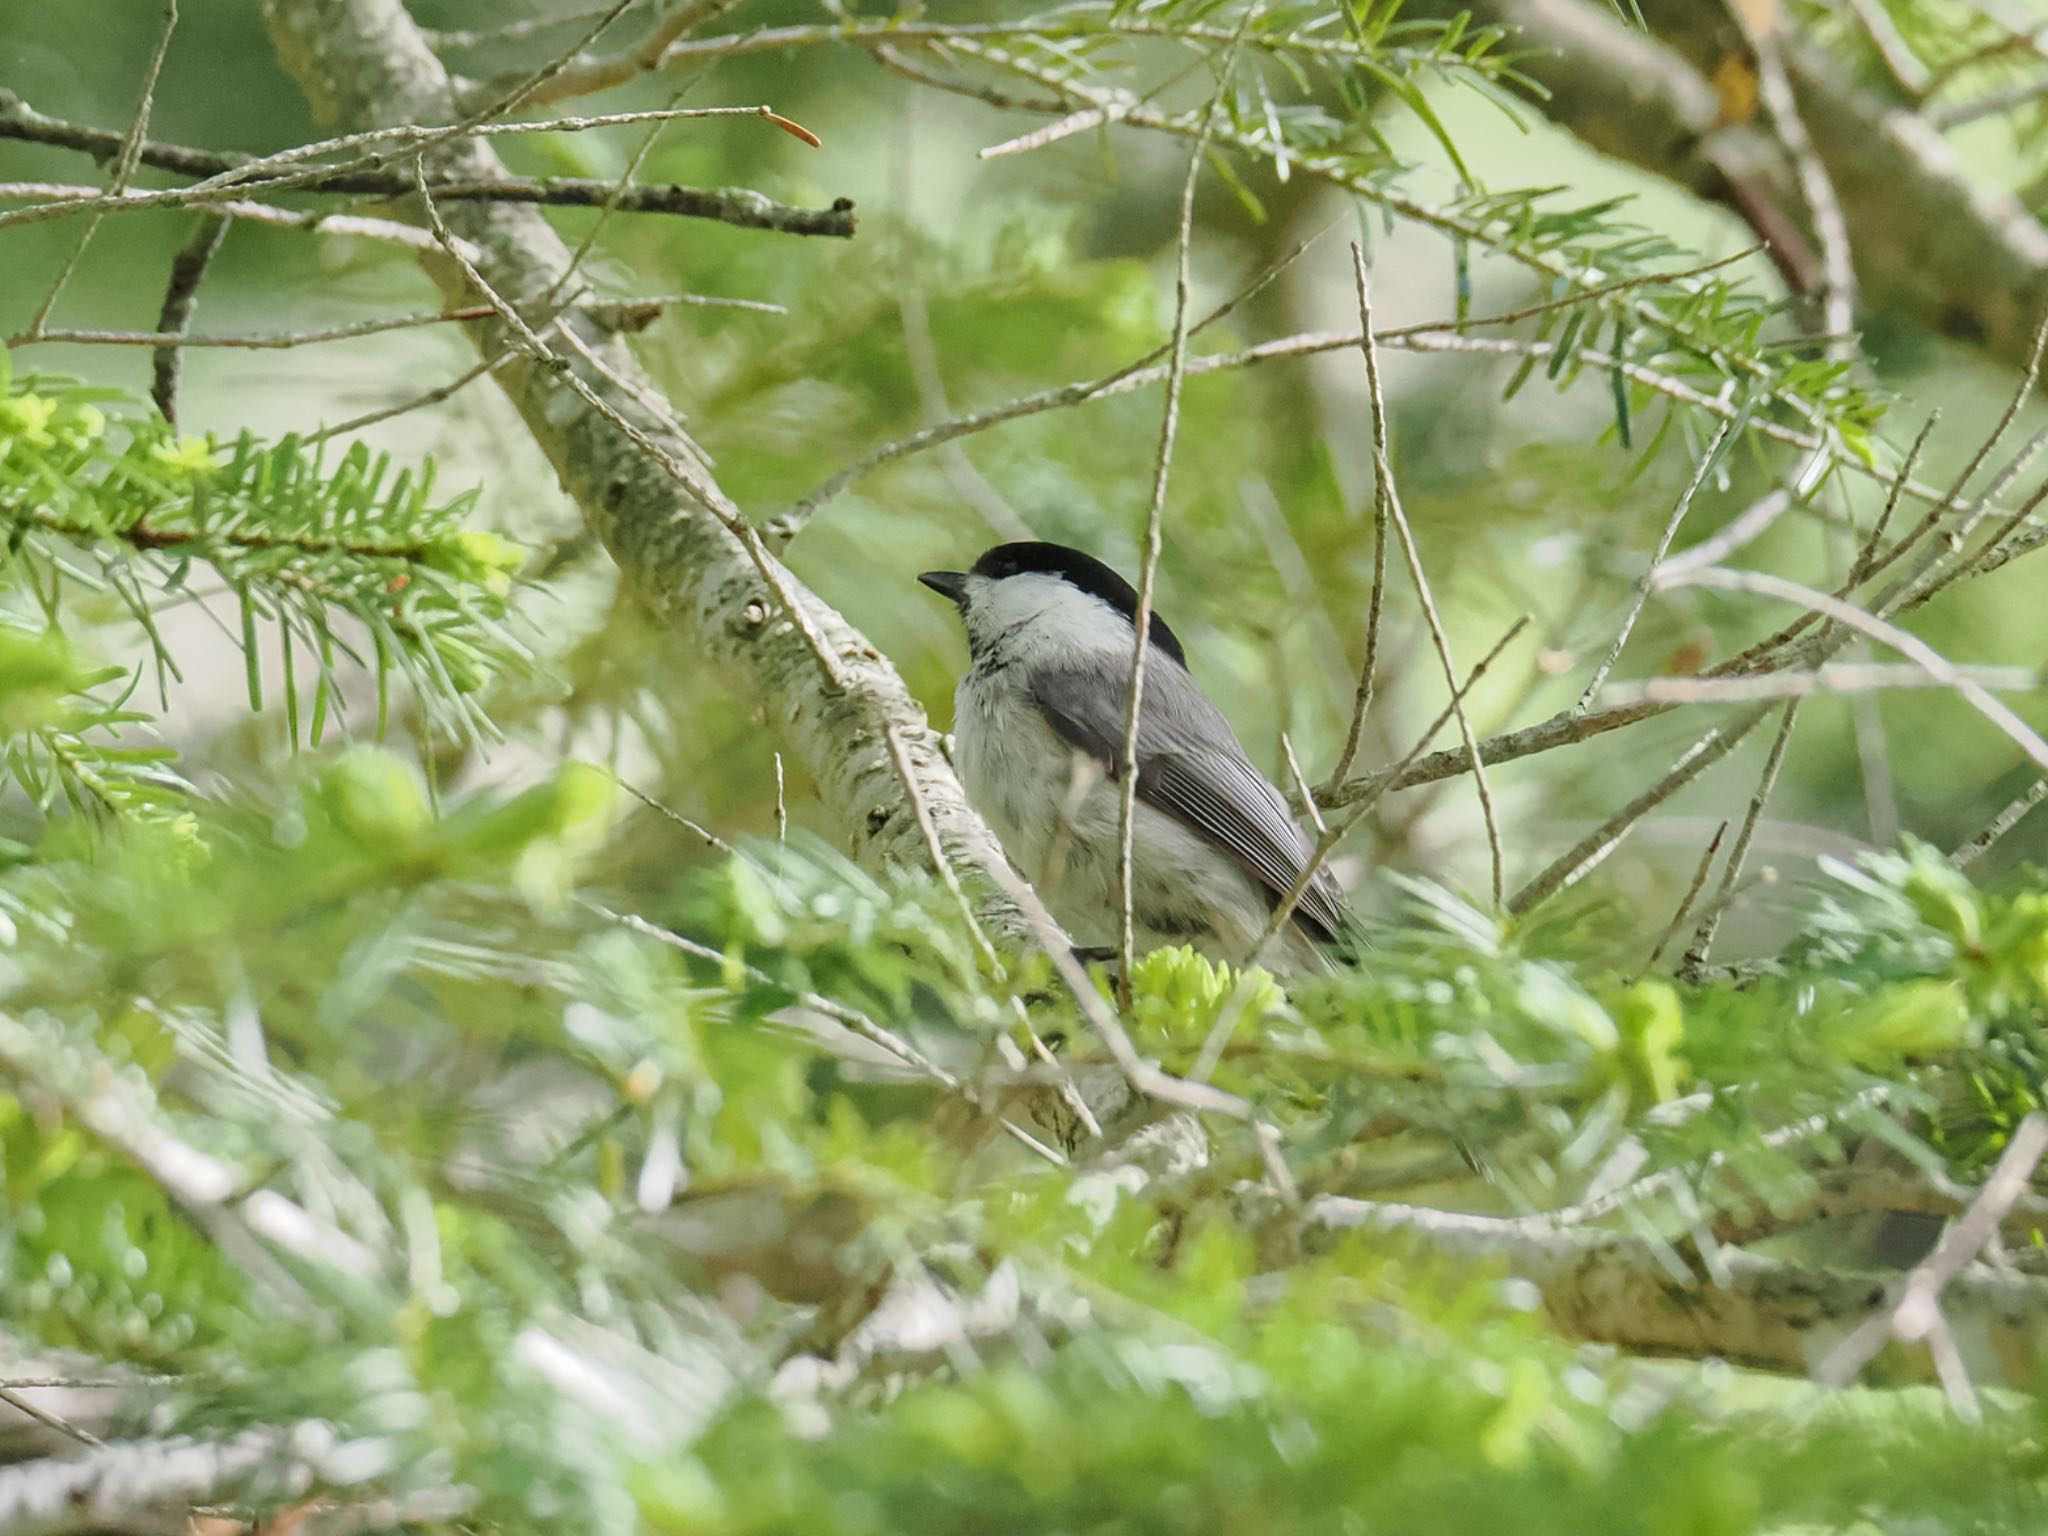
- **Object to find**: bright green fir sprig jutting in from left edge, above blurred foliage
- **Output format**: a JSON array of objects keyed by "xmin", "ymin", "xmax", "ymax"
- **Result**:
[{"xmin": 0, "ymin": 360, "xmax": 528, "ymax": 774}]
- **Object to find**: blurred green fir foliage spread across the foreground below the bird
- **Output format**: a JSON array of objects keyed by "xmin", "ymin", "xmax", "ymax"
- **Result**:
[{"xmin": 0, "ymin": 798, "xmax": 2044, "ymax": 1536}]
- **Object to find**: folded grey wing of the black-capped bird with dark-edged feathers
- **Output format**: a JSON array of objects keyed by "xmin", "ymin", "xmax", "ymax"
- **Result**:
[{"xmin": 1032, "ymin": 655, "xmax": 1350, "ymax": 940}]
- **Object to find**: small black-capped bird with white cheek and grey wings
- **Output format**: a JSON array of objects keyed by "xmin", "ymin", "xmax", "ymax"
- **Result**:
[{"xmin": 918, "ymin": 543, "xmax": 1354, "ymax": 967}]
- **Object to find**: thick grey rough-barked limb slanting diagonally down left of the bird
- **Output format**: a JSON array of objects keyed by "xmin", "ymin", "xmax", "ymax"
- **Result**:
[{"xmin": 262, "ymin": 0, "xmax": 1014, "ymax": 926}]
